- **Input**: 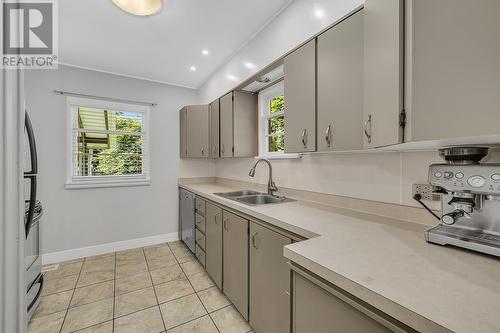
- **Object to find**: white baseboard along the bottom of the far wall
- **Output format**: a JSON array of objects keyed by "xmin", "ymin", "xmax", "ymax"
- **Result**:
[{"xmin": 42, "ymin": 232, "xmax": 179, "ymax": 265}]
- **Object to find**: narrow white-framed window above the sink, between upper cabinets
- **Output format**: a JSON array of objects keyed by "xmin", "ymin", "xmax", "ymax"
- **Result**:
[{"xmin": 259, "ymin": 81, "xmax": 285, "ymax": 157}]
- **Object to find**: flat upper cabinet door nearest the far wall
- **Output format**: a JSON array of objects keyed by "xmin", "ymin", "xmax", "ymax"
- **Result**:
[{"xmin": 187, "ymin": 105, "xmax": 210, "ymax": 158}]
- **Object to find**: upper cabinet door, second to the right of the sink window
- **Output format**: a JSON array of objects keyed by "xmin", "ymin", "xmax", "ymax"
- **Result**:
[{"xmin": 317, "ymin": 11, "xmax": 364, "ymax": 151}]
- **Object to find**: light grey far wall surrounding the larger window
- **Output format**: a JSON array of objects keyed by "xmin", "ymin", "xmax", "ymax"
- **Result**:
[{"xmin": 26, "ymin": 67, "xmax": 215, "ymax": 253}]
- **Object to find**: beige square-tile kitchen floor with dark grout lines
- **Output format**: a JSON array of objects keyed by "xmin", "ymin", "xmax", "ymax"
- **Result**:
[{"xmin": 29, "ymin": 242, "xmax": 252, "ymax": 333}]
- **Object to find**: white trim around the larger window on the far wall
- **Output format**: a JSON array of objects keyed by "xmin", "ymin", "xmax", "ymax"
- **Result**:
[{"xmin": 65, "ymin": 97, "xmax": 151, "ymax": 189}]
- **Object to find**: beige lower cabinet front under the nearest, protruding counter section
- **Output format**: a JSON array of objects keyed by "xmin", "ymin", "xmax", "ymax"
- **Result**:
[{"xmin": 292, "ymin": 268, "xmax": 416, "ymax": 333}]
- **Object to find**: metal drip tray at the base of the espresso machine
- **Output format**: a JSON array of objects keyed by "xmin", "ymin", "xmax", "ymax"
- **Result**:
[{"xmin": 425, "ymin": 224, "xmax": 500, "ymax": 257}]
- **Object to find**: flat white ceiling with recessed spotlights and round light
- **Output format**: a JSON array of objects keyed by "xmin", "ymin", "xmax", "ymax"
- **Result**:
[{"xmin": 59, "ymin": 0, "xmax": 293, "ymax": 88}]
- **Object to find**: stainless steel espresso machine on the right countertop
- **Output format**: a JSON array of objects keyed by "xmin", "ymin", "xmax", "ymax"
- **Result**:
[{"xmin": 425, "ymin": 147, "xmax": 500, "ymax": 257}]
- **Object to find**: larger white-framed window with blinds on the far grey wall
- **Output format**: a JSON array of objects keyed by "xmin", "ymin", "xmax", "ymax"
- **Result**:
[{"xmin": 66, "ymin": 97, "xmax": 150, "ymax": 188}]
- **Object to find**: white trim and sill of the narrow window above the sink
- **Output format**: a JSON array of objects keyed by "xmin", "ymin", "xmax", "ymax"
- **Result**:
[{"xmin": 257, "ymin": 81, "xmax": 301, "ymax": 159}]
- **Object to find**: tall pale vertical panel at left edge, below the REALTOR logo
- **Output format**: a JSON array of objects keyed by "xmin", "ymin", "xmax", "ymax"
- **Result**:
[{"xmin": 0, "ymin": 68, "xmax": 28, "ymax": 333}]
